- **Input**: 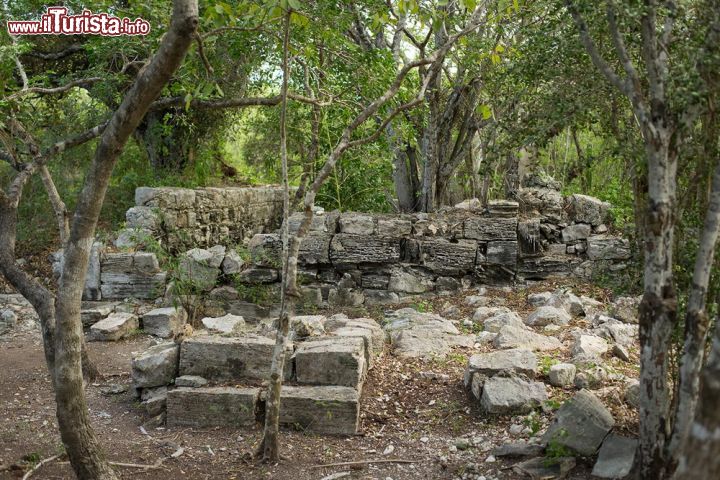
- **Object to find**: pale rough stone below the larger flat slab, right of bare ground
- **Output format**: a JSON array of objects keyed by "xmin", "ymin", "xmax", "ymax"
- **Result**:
[{"xmin": 480, "ymin": 377, "xmax": 547, "ymax": 414}]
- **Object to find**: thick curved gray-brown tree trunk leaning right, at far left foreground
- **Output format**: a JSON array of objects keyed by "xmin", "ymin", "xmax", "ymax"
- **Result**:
[{"xmin": 55, "ymin": 0, "xmax": 198, "ymax": 480}]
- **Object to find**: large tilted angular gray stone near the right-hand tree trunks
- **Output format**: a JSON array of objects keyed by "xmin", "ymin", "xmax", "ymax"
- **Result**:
[{"xmin": 543, "ymin": 390, "xmax": 615, "ymax": 456}]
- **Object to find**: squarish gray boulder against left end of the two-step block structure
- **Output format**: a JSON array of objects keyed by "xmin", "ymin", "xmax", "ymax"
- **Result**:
[{"xmin": 131, "ymin": 343, "xmax": 179, "ymax": 389}]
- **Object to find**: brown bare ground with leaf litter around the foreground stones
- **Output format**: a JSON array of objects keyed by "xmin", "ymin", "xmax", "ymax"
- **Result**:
[{"xmin": 0, "ymin": 284, "xmax": 635, "ymax": 480}]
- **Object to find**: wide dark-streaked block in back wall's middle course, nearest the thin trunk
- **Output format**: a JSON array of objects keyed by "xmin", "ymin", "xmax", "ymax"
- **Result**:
[{"xmin": 330, "ymin": 233, "xmax": 400, "ymax": 265}]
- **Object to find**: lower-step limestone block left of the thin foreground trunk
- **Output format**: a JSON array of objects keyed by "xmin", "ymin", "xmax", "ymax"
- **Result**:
[{"xmin": 167, "ymin": 387, "xmax": 260, "ymax": 428}]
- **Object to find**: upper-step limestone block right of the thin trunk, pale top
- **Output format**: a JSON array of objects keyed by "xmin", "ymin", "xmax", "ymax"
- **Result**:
[{"xmin": 294, "ymin": 337, "xmax": 367, "ymax": 389}]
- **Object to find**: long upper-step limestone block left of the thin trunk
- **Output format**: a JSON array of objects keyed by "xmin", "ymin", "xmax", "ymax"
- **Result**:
[{"xmin": 180, "ymin": 335, "xmax": 292, "ymax": 380}]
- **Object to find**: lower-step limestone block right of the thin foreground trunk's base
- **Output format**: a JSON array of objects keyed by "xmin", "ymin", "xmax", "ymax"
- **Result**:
[{"xmin": 280, "ymin": 386, "xmax": 360, "ymax": 435}]
